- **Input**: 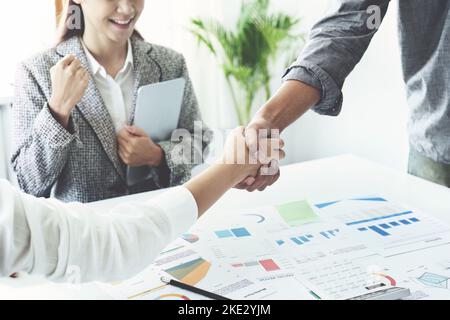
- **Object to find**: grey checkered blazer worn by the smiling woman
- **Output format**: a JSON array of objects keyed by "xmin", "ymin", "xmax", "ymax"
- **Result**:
[{"xmin": 11, "ymin": 36, "xmax": 211, "ymax": 202}]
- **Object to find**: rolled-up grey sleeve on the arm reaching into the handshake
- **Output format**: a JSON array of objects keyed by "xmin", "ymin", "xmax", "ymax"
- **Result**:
[{"xmin": 283, "ymin": 0, "xmax": 390, "ymax": 116}]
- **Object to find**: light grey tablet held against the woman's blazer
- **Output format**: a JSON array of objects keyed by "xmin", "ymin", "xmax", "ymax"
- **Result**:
[{"xmin": 127, "ymin": 78, "xmax": 186, "ymax": 186}]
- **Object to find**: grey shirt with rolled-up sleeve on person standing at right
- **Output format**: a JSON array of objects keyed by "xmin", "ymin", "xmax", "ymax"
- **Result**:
[{"xmin": 284, "ymin": 0, "xmax": 450, "ymax": 164}]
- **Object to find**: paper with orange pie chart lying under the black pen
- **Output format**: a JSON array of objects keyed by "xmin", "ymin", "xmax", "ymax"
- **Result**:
[{"xmin": 101, "ymin": 242, "xmax": 275, "ymax": 300}]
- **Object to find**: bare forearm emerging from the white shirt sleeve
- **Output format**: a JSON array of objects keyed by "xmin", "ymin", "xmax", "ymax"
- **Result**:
[{"xmin": 185, "ymin": 164, "xmax": 248, "ymax": 217}]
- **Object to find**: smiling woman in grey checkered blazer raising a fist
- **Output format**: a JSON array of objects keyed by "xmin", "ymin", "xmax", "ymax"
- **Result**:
[{"xmin": 12, "ymin": 0, "xmax": 211, "ymax": 202}]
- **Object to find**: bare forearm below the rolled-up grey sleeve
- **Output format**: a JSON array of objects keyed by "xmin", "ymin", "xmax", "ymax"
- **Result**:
[{"xmin": 255, "ymin": 80, "xmax": 320, "ymax": 131}]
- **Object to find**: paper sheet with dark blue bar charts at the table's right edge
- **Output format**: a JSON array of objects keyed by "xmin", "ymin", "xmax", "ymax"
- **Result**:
[{"xmin": 318, "ymin": 198, "xmax": 450, "ymax": 257}]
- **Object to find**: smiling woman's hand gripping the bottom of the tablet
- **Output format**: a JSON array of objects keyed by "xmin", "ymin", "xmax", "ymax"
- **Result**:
[{"xmin": 117, "ymin": 126, "xmax": 164, "ymax": 167}]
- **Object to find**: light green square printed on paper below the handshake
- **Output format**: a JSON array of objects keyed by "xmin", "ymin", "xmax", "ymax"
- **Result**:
[{"xmin": 276, "ymin": 201, "xmax": 319, "ymax": 227}]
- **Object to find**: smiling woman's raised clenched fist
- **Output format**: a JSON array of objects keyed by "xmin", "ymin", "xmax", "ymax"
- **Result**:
[{"xmin": 49, "ymin": 54, "xmax": 89, "ymax": 129}]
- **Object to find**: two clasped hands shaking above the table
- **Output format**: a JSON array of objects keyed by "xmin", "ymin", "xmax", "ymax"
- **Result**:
[{"xmin": 221, "ymin": 121, "xmax": 286, "ymax": 192}]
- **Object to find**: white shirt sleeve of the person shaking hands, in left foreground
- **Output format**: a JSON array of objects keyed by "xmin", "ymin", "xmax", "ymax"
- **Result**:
[{"xmin": 0, "ymin": 180, "xmax": 198, "ymax": 282}]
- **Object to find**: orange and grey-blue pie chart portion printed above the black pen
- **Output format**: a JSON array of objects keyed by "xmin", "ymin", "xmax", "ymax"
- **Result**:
[{"xmin": 165, "ymin": 258, "xmax": 211, "ymax": 286}]
